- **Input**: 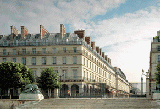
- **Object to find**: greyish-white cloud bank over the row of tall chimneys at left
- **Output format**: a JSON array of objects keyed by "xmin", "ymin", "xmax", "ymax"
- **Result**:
[{"xmin": 0, "ymin": 0, "xmax": 125, "ymax": 34}]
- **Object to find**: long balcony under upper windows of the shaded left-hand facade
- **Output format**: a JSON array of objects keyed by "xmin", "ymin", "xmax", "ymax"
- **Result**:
[{"xmin": 0, "ymin": 50, "xmax": 82, "ymax": 56}]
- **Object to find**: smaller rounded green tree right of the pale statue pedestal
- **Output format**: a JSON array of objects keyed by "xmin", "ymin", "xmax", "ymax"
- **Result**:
[{"xmin": 38, "ymin": 67, "xmax": 60, "ymax": 90}]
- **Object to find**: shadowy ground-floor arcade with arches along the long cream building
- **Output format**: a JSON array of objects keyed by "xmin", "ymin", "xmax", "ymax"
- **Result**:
[{"xmin": 59, "ymin": 82, "xmax": 129, "ymax": 98}]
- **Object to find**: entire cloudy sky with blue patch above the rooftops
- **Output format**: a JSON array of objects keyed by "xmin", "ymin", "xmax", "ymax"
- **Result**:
[{"xmin": 0, "ymin": 0, "xmax": 160, "ymax": 82}]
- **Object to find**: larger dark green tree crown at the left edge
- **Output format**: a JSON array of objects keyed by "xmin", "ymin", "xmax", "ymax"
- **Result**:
[{"xmin": 0, "ymin": 62, "xmax": 34, "ymax": 89}]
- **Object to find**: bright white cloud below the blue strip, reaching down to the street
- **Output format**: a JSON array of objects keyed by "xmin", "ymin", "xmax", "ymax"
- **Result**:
[{"xmin": 90, "ymin": 7, "xmax": 160, "ymax": 82}]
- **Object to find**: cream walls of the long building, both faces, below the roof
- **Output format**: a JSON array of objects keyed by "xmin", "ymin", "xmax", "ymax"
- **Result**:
[{"xmin": 0, "ymin": 45, "xmax": 129, "ymax": 96}]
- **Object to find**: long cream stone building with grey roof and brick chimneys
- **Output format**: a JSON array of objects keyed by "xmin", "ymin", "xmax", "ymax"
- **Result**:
[{"xmin": 0, "ymin": 24, "xmax": 130, "ymax": 96}]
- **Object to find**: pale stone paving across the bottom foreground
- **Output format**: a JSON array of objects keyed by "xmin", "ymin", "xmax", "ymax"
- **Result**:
[{"xmin": 17, "ymin": 98, "xmax": 160, "ymax": 109}]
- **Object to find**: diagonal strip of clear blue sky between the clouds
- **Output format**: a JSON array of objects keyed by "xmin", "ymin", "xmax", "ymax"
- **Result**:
[{"xmin": 92, "ymin": 0, "xmax": 157, "ymax": 22}]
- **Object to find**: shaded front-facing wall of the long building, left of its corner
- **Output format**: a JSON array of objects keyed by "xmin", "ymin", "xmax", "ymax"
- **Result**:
[{"xmin": 0, "ymin": 45, "xmax": 82, "ymax": 76}]
